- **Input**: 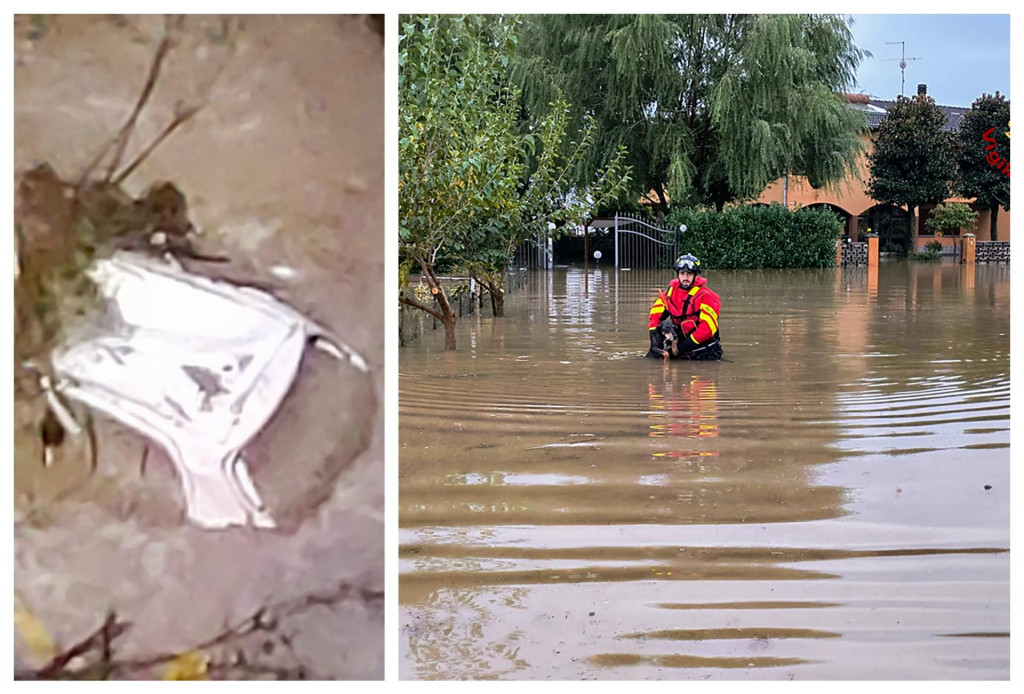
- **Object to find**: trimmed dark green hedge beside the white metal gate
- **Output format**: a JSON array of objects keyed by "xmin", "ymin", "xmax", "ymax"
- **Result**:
[{"xmin": 665, "ymin": 204, "xmax": 843, "ymax": 269}]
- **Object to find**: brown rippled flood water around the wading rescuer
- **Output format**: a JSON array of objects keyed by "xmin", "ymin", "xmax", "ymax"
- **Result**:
[{"xmin": 399, "ymin": 262, "xmax": 1010, "ymax": 680}]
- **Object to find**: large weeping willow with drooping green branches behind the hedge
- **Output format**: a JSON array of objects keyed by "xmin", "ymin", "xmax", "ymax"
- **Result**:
[{"xmin": 515, "ymin": 14, "xmax": 867, "ymax": 213}]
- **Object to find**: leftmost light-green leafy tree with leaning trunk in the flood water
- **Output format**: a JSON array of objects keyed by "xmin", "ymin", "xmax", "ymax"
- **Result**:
[{"xmin": 398, "ymin": 16, "xmax": 522, "ymax": 349}]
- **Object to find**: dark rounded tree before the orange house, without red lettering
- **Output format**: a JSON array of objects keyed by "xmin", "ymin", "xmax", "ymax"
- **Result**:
[{"xmin": 867, "ymin": 94, "xmax": 956, "ymax": 252}]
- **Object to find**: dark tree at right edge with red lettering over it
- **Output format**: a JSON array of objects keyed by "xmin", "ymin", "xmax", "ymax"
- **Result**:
[{"xmin": 954, "ymin": 92, "xmax": 1010, "ymax": 241}]
